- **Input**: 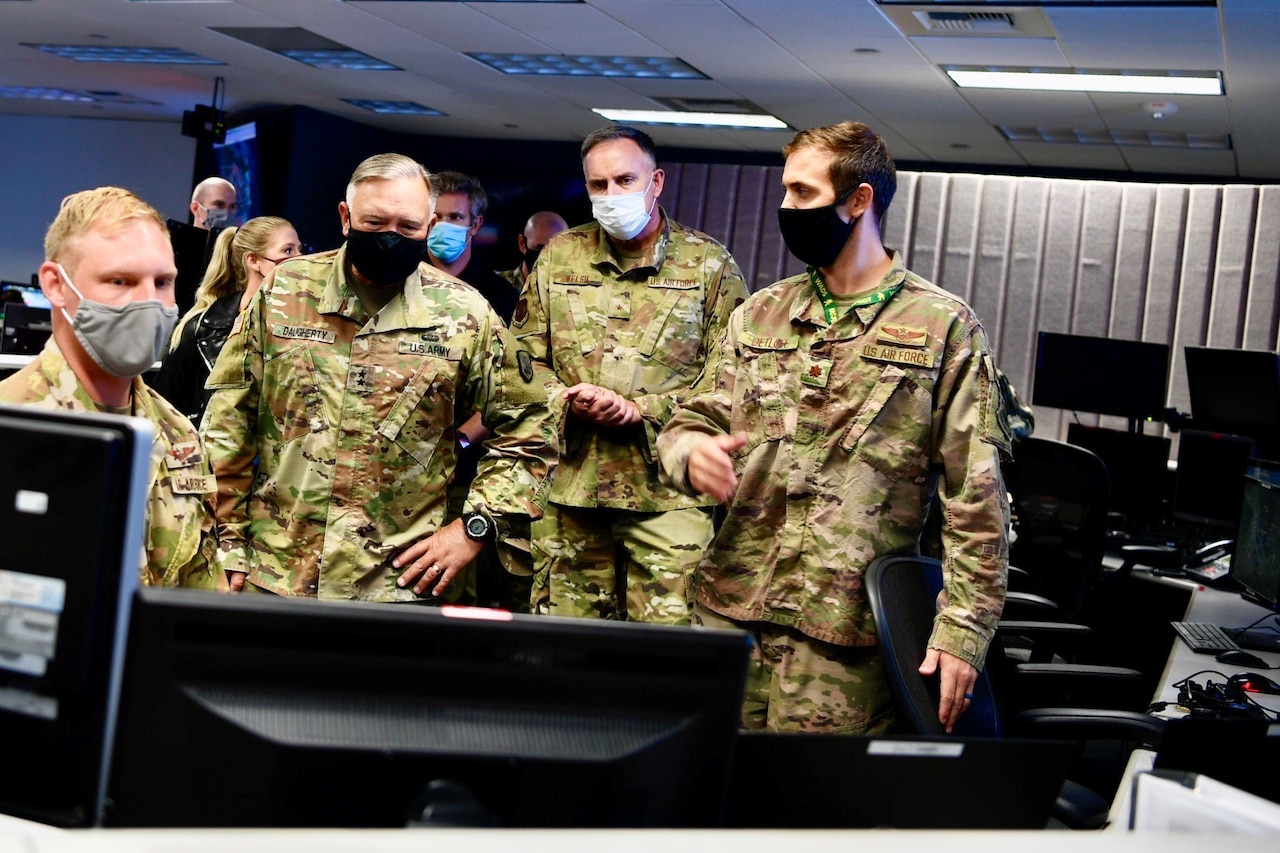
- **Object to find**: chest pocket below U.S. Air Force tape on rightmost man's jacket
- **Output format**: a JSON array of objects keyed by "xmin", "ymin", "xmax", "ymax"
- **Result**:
[{"xmin": 840, "ymin": 364, "xmax": 933, "ymax": 482}]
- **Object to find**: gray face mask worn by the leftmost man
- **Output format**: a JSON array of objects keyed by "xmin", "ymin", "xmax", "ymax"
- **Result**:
[{"xmin": 58, "ymin": 264, "xmax": 178, "ymax": 379}]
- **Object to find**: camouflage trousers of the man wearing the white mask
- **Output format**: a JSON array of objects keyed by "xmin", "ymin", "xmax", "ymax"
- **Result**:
[{"xmin": 530, "ymin": 503, "xmax": 713, "ymax": 625}]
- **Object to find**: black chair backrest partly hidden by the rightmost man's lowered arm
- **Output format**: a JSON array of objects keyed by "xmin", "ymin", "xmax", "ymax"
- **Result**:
[{"xmin": 865, "ymin": 555, "xmax": 1001, "ymax": 738}]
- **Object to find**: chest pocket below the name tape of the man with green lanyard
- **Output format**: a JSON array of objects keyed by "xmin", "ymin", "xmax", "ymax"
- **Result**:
[{"xmin": 730, "ymin": 333, "xmax": 799, "ymax": 456}]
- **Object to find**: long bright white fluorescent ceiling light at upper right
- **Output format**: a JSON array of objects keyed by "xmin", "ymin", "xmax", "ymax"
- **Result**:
[{"xmin": 943, "ymin": 67, "xmax": 1222, "ymax": 95}]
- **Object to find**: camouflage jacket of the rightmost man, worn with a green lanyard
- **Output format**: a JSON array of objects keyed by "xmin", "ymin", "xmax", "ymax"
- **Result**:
[{"xmin": 658, "ymin": 254, "xmax": 1010, "ymax": 666}]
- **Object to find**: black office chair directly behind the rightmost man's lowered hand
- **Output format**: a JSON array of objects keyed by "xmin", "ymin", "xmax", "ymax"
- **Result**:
[{"xmin": 865, "ymin": 555, "xmax": 1162, "ymax": 829}]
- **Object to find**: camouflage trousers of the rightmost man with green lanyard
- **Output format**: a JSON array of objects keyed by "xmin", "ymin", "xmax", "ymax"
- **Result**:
[{"xmin": 694, "ymin": 606, "xmax": 893, "ymax": 734}]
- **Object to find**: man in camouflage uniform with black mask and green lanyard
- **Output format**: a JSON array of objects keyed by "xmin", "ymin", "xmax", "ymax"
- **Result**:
[{"xmin": 658, "ymin": 122, "xmax": 1009, "ymax": 733}]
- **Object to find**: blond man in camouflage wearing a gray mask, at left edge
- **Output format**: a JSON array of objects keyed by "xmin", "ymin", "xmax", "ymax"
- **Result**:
[{"xmin": 0, "ymin": 187, "xmax": 217, "ymax": 589}]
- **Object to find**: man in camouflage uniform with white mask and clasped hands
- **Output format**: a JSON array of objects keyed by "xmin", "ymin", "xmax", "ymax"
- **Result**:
[{"xmin": 512, "ymin": 127, "xmax": 746, "ymax": 624}]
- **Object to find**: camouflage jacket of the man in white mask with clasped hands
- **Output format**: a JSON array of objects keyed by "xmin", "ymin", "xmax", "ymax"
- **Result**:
[{"xmin": 511, "ymin": 207, "xmax": 746, "ymax": 512}]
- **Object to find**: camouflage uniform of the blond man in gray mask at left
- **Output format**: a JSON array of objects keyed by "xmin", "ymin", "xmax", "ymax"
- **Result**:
[{"xmin": 0, "ymin": 338, "xmax": 218, "ymax": 589}]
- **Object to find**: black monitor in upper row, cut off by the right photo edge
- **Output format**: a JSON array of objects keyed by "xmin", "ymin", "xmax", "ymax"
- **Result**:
[{"xmin": 1184, "ymin": 347, "xmax": 1280, "ymax": 434}]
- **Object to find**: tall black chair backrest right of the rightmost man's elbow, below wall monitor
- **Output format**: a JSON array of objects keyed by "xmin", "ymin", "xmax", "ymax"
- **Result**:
[{"xmin": 1006, "ymin": 438, "xmax": 1111, "ymax": 621}]
